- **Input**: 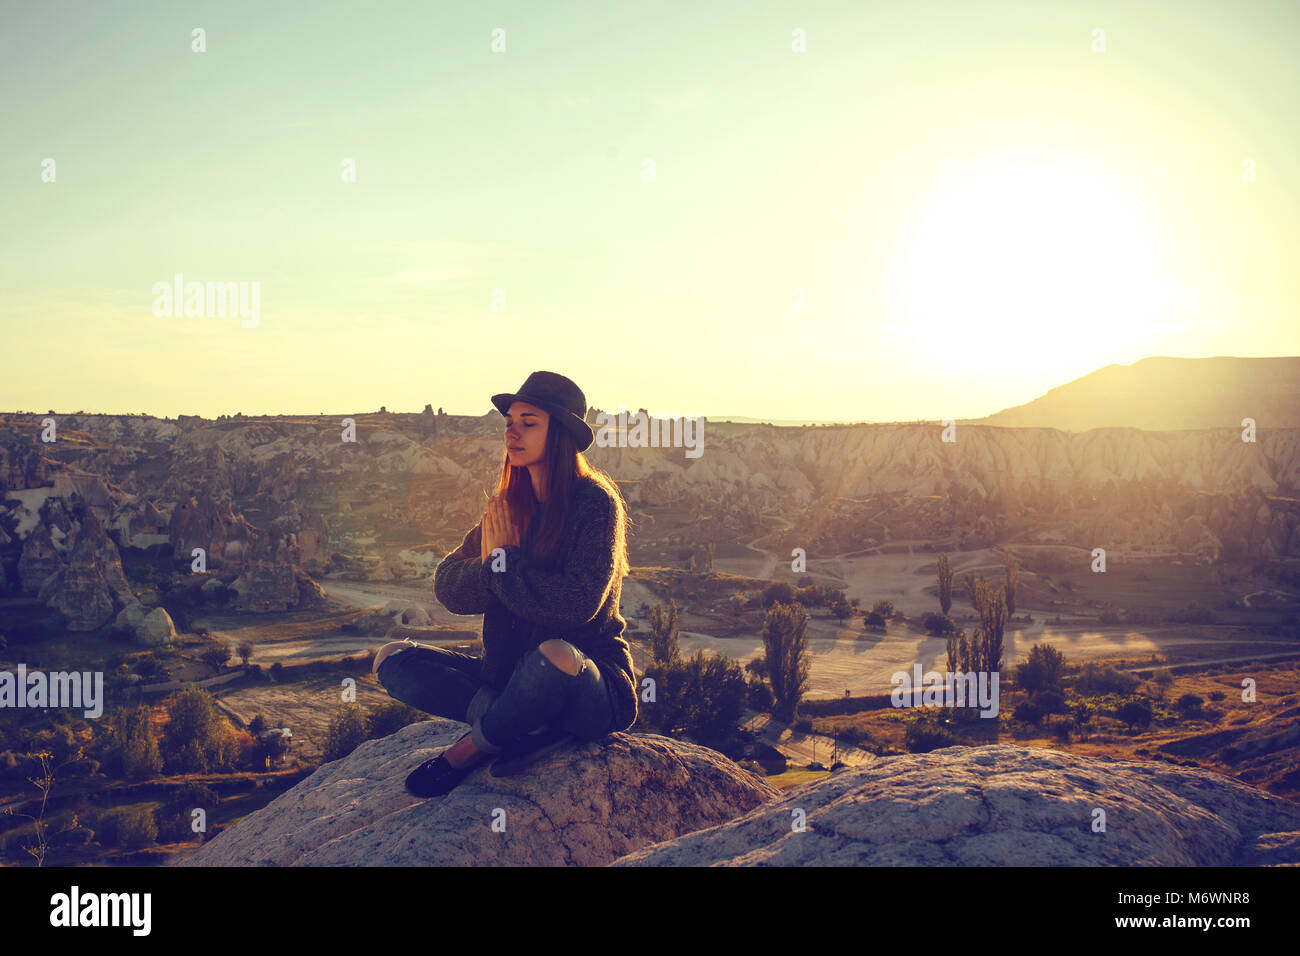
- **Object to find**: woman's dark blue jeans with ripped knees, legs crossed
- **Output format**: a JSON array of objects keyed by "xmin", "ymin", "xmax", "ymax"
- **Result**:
[{"xmin": 376, "ymin": 641, "xmax": 614, "ymax": 753}]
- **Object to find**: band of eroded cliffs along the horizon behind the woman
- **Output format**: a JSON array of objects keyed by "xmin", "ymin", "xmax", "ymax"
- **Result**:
[{"xmin": 0, "ymin": 412, "xmax": 1300, "ymax": 626}]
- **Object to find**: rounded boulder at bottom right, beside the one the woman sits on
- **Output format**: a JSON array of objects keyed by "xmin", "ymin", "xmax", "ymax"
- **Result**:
[{"xmin": 614, "ymin": 744, "xmax": 1300, "ymax": 866}]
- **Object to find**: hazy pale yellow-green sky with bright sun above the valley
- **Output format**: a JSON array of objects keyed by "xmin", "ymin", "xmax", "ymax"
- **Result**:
[{"xmin": 0, "ymin": 0, "xmax": 1300, "ymax": 421}]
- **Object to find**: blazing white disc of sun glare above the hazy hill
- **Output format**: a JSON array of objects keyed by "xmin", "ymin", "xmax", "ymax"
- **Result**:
[{"xmin": 897, "ymin": 161, "xmax": 1166, "ymax": 364}]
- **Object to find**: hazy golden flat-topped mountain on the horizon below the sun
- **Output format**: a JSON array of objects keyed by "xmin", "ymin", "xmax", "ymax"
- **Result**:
[{"xmin": 966, "ymin": 355, "xmax": 1300, "ymax": 432}]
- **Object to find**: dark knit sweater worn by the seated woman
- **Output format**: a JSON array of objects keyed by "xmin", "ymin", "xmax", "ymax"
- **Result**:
[{"xmin": 433, "ymin": 477, "xmax": 637, "ymax": 731}]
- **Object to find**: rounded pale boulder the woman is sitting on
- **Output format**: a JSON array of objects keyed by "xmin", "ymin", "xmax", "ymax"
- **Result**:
[{"xmin": 181, "ymin": 719, "xmax": 779, "ymax": 866}]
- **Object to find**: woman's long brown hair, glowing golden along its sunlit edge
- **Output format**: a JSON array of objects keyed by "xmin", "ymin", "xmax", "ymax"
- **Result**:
[{"xmin": 494, "ymin": 415, "xmax": 632, "ymax": 579}]
